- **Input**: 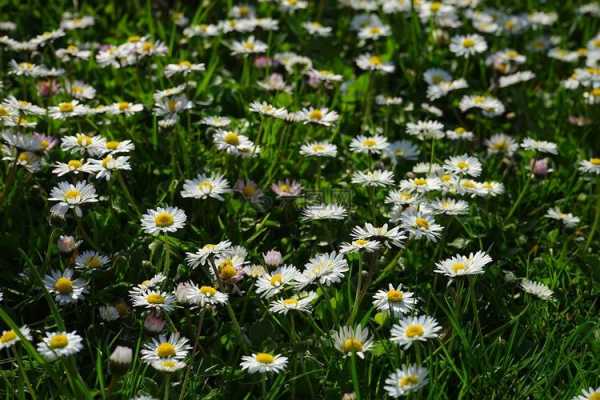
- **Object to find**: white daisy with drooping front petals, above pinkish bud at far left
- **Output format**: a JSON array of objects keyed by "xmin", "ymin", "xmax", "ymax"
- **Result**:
[{"xmin": 48, "ymin": 181, "xmax": 98, "ymax": 218}]
